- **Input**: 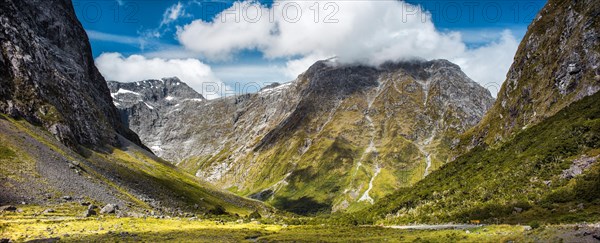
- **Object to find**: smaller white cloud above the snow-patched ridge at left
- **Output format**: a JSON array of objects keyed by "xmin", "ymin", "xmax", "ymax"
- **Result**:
[{"xmin": 96, "ymin": 53, "xmax": 226, "ymax": 99}]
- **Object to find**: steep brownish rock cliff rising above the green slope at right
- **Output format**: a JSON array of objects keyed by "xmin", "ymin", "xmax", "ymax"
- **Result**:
[{"xmin": 465, "ymin": 0, "xmax": 600, "ymax": 147}]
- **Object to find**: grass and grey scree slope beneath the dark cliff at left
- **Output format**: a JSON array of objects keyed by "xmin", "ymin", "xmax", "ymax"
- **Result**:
[{"xmin": 0, "ymin": 115, "xmax": 270, "ymax": 215}]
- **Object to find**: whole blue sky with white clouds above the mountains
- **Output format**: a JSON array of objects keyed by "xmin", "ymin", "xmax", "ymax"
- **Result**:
[{"xmin": 73, "ymin": 0, "xmax": 546, "ymax": 99}]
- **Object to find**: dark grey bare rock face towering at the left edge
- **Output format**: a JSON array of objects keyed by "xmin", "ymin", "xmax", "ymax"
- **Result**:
[{"xmin": 0, "ymin": 0, "xmax": 139, "ymax": 147}]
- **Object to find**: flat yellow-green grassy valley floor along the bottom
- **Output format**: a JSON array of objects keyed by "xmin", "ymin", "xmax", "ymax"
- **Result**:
[{"xmin": 0, "ymin": 206, "xmax": 600, "ymax": 242}]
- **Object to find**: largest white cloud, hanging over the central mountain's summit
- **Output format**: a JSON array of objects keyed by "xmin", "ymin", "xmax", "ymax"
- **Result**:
[{"xmin": 177, "ymin": 0, "xmax": 517, "ymax": 95}]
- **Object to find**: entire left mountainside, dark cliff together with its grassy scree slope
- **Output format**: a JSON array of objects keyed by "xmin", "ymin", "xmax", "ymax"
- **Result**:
[{"xmin": 0, "ymin": 0, "xmax": 268, "ymax": 216}]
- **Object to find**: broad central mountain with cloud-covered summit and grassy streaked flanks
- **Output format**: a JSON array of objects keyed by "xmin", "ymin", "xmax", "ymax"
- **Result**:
[{"xmin": 113, "ymin": 60, "xmax": 493, "ymax": 213}]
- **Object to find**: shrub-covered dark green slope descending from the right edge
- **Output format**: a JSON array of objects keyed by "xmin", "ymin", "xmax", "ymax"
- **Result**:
[{"xmin": 344, "ymin": 93, "xmax": 600, "ymax": 224}]
